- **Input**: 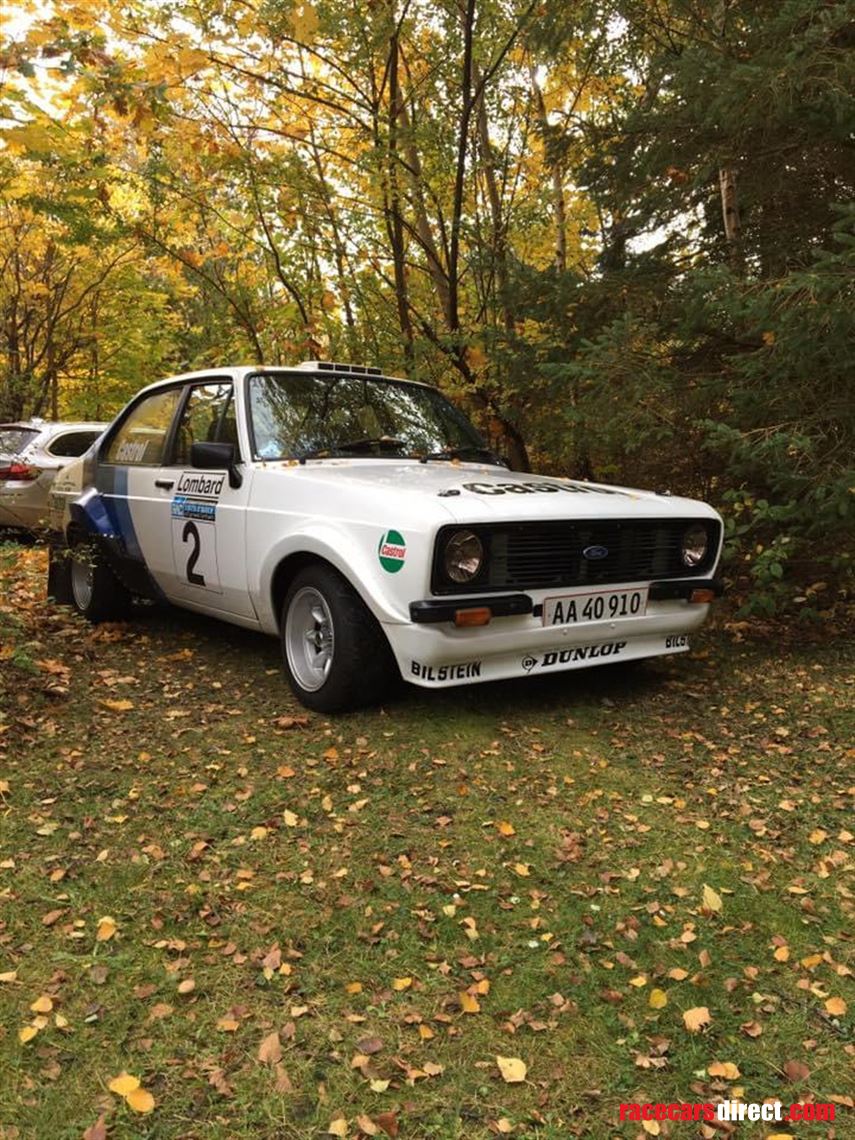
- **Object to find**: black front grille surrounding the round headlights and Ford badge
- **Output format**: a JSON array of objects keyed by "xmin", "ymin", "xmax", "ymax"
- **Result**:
[{"xmin": 432, "ymin": 519, "xmax": 720, "ymax": 594}]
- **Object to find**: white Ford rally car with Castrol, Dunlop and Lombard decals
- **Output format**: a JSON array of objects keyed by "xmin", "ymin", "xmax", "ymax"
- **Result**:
[{"xmin": 50, "ymin": 361, "xmax": 722, "ymax": 711}]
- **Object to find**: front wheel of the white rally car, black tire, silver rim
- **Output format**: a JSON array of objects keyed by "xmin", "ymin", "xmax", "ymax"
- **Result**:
[{"xmin": 279, "ymin": 562, "xmax": 400, "ymax": 713}]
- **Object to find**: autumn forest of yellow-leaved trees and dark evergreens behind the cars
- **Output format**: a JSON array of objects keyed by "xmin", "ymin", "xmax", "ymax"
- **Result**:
[{"xmin": 0, "ymin": 0, "xmax": 855, "ymax": 618}]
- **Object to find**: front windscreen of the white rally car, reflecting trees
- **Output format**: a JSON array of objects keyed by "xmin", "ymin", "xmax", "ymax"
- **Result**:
[{"xmin": 249, "ymin": 373, "xmax": 483, "ymax": 459}]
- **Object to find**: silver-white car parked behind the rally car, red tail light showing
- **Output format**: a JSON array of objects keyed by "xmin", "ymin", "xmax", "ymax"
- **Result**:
[{"xmin": 0, "ymin": 420, "xmax": 107, "ymax": 531}]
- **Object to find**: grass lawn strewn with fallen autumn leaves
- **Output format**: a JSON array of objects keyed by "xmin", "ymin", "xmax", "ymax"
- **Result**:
[{"xmin": 0, "ymin": 547, "xmax": 855, "ymax": 1140}]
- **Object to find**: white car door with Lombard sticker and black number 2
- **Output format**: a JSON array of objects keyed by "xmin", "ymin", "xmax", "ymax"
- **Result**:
[{"xmin": 160, "ymin": 376, "xmax": 255, "ymax": 620}]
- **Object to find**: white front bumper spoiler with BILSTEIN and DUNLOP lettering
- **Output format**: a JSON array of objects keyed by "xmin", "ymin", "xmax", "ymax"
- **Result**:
[{"xmin": 383, "ymin": 579, "xmax": 722, "ymax": 689}]
